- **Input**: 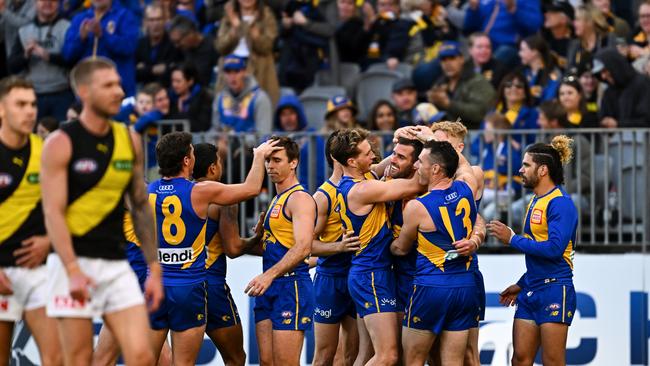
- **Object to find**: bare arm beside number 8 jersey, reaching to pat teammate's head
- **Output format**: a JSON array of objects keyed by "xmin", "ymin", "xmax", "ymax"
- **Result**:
[{"xmin": 192, "ymin": 140, "xmax": 281, "ymax": 207}]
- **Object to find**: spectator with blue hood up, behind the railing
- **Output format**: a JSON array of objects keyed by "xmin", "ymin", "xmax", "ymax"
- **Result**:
[{"xmin": 273, "ymin": 95, "xmax": 327, "ymax": 190}]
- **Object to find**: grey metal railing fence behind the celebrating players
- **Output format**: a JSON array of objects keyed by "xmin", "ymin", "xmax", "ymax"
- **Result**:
[{"xmin": 145, "ymin": 121, "xmax": 650, "ymax": 252}]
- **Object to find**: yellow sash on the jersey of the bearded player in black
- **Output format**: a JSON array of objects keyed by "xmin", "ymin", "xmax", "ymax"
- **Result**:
[{"xmin": 65, "ymin": 122, "xmax": 135, "ymax": 236}]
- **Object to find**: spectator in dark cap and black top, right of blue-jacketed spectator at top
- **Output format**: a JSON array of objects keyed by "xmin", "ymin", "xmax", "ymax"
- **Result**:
[{"xmin": 542, "ymin": 0, "xmax": 575, "ymax": 69}]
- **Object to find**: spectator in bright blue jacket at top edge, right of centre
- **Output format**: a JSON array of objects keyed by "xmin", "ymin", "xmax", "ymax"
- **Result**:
[{"xmin": 463, "ymin": 0, "xmax": 542, "ymax": 67}]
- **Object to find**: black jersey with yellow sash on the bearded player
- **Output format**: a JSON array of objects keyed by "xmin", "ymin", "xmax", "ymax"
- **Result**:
[{"xmin": 61, "ymin": 121, "xmax": 135, "ymax": 259}]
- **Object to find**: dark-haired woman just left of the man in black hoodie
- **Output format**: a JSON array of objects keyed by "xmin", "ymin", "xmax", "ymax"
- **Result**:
[{"xmin": 558, "ymin": 75, "xmax": 599, "ymax": 128}]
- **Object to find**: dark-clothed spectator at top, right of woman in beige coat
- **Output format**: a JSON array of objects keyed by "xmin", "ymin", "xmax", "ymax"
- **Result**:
[{"xmin": 279, "ymin": 0, "xmax": 335, "ymax": 93}]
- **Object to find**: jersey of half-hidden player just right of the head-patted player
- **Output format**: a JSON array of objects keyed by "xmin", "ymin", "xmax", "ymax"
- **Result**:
[{"xmin": 316, "ymin": 179, "xmax": 352, "ymax": 275}]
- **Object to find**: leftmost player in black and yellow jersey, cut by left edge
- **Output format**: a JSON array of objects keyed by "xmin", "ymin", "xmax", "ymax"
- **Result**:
[{"xmin": 0, "ymin": 76, "xmax": 62, "ymax": 365}]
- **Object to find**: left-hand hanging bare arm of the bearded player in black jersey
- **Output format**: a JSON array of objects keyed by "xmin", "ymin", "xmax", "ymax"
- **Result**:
[{"xmin": 41, "ymin": 131, "xmax": 93, "ymax": 301}]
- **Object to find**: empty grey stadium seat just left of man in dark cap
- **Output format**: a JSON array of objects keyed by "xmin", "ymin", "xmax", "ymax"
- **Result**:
[{"xmin": 357, "ymin": 70, "xmax": 401, "ymax": 121}]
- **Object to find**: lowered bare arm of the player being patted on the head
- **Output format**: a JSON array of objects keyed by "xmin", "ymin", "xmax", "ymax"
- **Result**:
[{"xmin": 244, "ymin": 192, "xmax": 316, "ymax": 296}]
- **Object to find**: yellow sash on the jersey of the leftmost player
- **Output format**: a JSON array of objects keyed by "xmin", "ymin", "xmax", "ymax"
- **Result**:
[{"xmin": 0, "ymin": 134, "xmax": 43, "ymax": 243}]
